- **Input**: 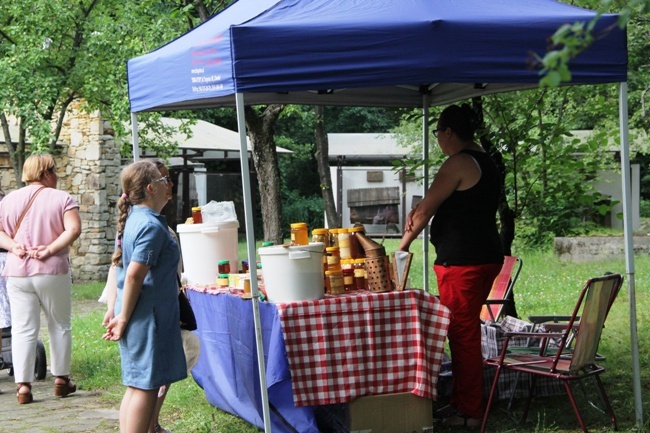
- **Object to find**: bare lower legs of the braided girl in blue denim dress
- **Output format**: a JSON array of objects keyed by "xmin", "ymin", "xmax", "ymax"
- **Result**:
[{"xmin": 120, "ymin": 386, "xmax": 158, "ymax": 433}]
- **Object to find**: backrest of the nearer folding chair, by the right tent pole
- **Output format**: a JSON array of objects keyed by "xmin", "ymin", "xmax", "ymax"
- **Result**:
[{"xmin": 567, "ymin": 274, "xmax": 623, "ymax": 371}]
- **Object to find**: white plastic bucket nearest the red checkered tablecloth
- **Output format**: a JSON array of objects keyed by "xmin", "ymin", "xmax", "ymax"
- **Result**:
[{"xmin": 258, "ymin": 242, "xmax": 325, "ymax": 303}]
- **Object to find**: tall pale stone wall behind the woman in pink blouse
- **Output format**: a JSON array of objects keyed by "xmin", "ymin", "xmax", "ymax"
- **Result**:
[{"xmin": 0, "ymin": 104, "xmax": 121, "ymax": 283}]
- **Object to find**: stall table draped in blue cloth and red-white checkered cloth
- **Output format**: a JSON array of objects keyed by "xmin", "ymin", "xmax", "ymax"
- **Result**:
[{"xmin": 188, "ymin": 287, "xmax": 449, "ymax": 433}]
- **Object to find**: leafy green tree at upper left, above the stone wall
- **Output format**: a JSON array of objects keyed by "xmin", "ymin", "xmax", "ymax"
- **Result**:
[{"xmin": 0, "ymin": 0, "xmax": 230, "ymax": 184}]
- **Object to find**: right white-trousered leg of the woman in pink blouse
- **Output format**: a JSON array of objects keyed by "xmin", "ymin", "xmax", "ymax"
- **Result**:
[{"xmin": 33, "ymin": 274, "xmax": 72, "ymax": 376}]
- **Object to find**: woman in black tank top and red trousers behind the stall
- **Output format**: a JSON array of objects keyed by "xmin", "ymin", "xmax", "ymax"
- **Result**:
[{"xmin": 398, "ymin": 104, "xmax": 503, "ymax": 426}]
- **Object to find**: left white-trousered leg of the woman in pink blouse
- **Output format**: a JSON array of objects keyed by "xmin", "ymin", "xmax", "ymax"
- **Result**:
[{"xmin": 7, "ymin": 277, "xmax": 41, "ymax": 383}]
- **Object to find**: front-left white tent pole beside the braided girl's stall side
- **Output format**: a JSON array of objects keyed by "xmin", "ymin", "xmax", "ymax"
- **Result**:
[{"xmin": 235, "ymin": 93, "xmax": 272, "ymax": 433}]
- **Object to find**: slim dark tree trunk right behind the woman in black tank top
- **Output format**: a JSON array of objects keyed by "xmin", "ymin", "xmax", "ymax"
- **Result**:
[{"xmin": 472, "ymin": 96, "xmax": 515, "ymax": 256}]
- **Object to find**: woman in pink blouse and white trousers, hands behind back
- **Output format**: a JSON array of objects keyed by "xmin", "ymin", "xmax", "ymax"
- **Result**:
[{"xmin": 0, "ymin": 154, "xmax": 81, "ymax": 404}]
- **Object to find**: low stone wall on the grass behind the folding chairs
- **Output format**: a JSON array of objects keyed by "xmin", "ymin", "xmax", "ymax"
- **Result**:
[{"xmin": 555, "ymin": 236, "xmax": 650, "ymax": 263}]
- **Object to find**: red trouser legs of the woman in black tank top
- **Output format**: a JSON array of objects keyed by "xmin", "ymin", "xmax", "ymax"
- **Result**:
[{"xmin": 434, "ymin": 265, "xmax": 501, "ymax": 418}]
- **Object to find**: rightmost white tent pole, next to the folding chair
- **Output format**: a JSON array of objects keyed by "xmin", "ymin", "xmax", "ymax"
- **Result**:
[{"xmin": 618, "ymin": 82, "xmax": 643, "ymax": 429}]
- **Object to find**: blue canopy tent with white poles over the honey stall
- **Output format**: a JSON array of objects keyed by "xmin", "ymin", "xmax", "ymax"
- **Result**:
[{"xmin": 127, "ymin": 0, "xmax": 642, "ymax": 431}]
